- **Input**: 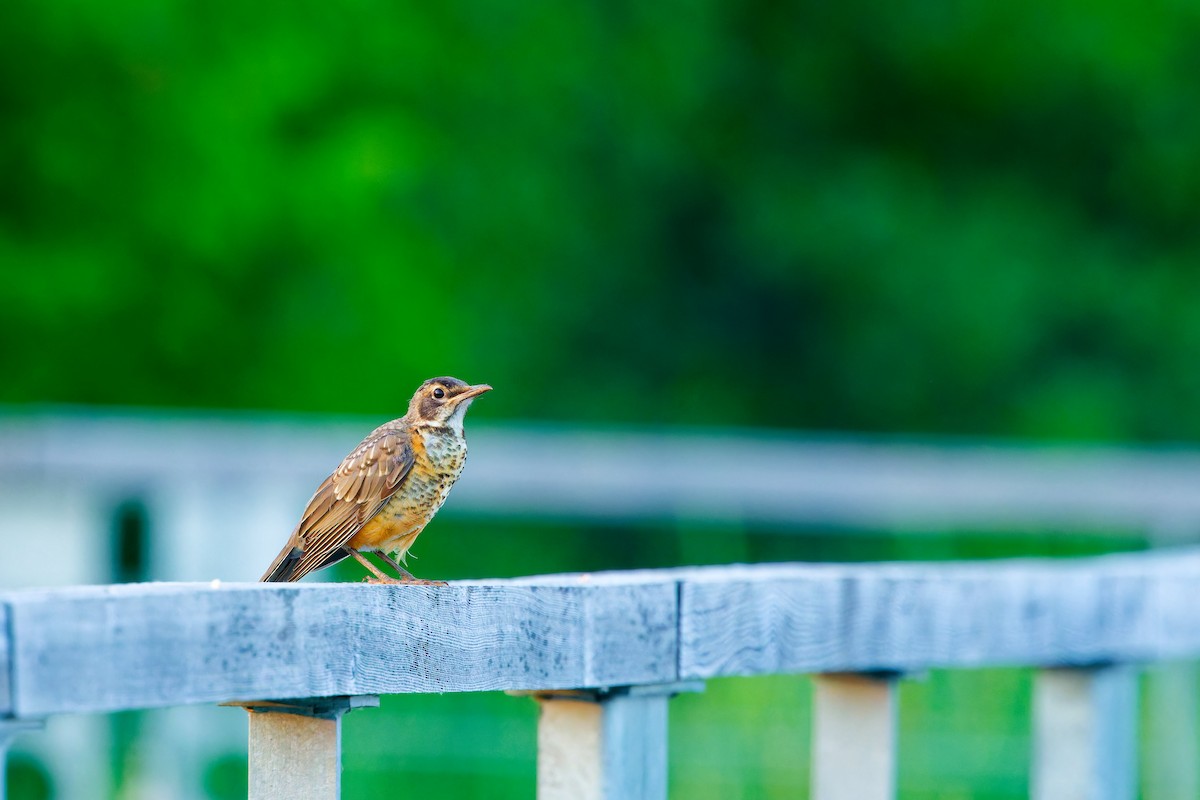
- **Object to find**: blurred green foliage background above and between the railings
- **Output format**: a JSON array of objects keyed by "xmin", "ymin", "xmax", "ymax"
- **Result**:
[{"xmin": 0, "ymin": 0, "xmax": 1200, "ymax": 799}]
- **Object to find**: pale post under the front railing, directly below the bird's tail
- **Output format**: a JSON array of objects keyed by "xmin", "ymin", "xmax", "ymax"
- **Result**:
[{"xmin": 232, "ymin": 694, "xmax": 379, "ymax": 800}]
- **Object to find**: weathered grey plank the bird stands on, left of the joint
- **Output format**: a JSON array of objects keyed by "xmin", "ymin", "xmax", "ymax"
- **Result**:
[{"xmin": 0, "ymin": 583, "xmax": 677, "ymax": 716}]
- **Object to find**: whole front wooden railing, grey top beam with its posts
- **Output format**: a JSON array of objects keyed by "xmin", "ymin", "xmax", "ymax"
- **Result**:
[{"xmin": 0, "ymin": 549, "xmax": 1200, "ymax": 800}]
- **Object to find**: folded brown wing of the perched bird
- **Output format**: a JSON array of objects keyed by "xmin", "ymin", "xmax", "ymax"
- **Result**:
[{"xmin": 262, "ymin": 425, "xmax": 413, "ymax": 581}]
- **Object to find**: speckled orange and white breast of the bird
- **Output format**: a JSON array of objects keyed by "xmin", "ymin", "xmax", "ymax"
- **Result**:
[{"xmin": 350, "ymin": 428, "xmax": 467, "ymax": 558}]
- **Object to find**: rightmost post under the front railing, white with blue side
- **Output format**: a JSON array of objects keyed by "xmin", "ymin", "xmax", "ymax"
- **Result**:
[{"xmin": 1030, "ymin": 664, "xmax": 1138, "ymax": 800}]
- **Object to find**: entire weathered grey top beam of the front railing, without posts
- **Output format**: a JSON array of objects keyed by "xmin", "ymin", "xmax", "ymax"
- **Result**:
[{"xmin": 0, "ymin": 549, "xmax": 1200, "ymax": 718}]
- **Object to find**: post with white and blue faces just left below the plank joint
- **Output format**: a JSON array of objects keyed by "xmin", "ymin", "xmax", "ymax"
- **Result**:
[{"xmin": 534, "ymin": 681, "xmax": 703, "ymax": 800}]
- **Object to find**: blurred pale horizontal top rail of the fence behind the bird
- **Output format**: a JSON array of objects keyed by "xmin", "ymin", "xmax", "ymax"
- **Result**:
[{"xmin": 7, "ymin": 411, "xmax": 1200, "ymax": 556}]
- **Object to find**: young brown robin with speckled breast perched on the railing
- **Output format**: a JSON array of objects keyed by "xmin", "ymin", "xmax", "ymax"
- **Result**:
[{"xmin": 262, "ymin": 378, "xmax": 492, "ymax": 583}]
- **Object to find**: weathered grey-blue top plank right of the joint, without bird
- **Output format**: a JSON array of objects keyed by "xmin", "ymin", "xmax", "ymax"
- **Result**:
[{"xmin": 679, "ymin": 549, "xmax": 1200, "ymax": 679}]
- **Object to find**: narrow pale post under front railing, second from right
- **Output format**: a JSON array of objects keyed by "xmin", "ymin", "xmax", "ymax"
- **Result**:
[{"xmin": 812, "ymin": 673, "xmax": 899, "ymax": 800}]
